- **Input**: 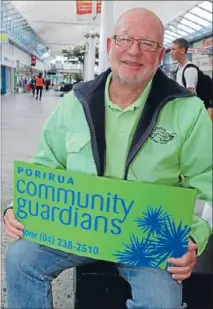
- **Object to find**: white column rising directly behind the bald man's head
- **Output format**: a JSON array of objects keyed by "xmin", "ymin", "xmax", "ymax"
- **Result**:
[{"xmin": 98, "ymin": 1, "xmax": 114, "ymax": 74}]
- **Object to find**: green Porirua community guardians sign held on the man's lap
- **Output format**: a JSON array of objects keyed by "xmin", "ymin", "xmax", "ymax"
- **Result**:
[{"xmin": 14, "ymin": 161, "xmax": 196, "ymax": 269}]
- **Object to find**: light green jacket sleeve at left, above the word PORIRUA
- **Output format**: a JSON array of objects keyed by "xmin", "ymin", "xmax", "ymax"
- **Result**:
[{"xmin": 3, "ymin": 98, "xmax": 66, "ymax": 216}]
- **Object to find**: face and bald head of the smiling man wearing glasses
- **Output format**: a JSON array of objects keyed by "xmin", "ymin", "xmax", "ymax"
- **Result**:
[{"xmin": 107, "ymin": 12, "xmax": 165, "ymax": 84}]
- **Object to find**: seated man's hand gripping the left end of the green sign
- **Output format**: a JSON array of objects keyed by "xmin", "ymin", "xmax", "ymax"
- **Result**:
[{"xmin": 4, "ymin": 209, "xmax": 24, "ymax": 239}]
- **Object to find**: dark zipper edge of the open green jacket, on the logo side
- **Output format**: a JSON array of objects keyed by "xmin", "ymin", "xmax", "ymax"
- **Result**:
[{"xmin": 124, "ymin": 94, "xmax": 192, "ymax": 180}]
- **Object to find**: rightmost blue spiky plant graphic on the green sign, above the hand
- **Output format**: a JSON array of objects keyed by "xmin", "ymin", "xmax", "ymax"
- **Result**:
[{"xmin": 153, "ymin": 218, "xmax": 190, "ymax": 267}]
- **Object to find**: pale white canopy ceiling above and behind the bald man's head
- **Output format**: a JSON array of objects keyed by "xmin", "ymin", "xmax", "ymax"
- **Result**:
[{"xmin": 5, "ymin": 1, "xmax": 213, "ymax": 55}]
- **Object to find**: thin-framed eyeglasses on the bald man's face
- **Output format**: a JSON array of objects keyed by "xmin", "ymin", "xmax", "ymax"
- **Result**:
[{"xmin": 112, "ymin": 35, "xmax": 162, "ymax": 52}]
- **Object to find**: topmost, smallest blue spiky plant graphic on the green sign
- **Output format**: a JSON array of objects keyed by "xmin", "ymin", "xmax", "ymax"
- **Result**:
[{"xmin": 135, "ymin": 206, "xmax": 168, "ymax": 239}]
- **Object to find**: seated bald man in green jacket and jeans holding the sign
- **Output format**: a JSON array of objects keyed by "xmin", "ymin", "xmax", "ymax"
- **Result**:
[{"xmin": 4, "ymin": 9, "xmax": 212, "ymax": 309}]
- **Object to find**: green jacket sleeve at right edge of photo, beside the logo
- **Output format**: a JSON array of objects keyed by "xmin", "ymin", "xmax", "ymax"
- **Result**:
[{"xmin": 180, "ymin": 105, "xmax": 213, "ymax": 255}]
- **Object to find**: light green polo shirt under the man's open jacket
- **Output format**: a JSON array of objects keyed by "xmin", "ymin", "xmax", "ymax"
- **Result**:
[{"xmin": 105, "ymin": 74, "xmax": 152, "ymax": 179}]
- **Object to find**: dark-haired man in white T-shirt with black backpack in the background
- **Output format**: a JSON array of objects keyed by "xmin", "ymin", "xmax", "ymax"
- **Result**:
[{"xmin": 171, "ymin": 38, "xmax": 198, "ymax": 94}]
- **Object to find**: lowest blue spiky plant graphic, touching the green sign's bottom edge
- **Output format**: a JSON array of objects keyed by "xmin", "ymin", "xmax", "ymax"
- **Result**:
[{"xmin": 114, "ymin": 235, "xmax": 158, "ymax": 267}]
